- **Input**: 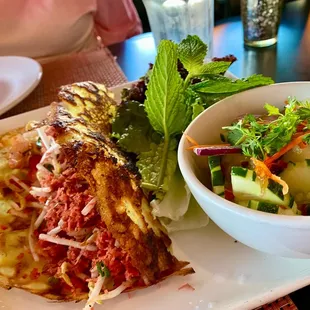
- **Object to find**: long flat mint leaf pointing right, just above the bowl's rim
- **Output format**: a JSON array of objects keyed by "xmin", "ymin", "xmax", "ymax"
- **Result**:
[{"xmin": 191, "ymin": 75, "xmax": 274, "ymax": 94}]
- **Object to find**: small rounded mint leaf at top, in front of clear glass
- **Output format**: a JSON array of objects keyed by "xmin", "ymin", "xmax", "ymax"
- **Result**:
[{"xmin": 178, "ymin": 35, "xmax": 208, "ymax": 73}]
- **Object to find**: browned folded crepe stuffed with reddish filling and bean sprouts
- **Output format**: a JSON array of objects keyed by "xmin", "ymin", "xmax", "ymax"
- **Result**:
[{"xmin": 0, "ymin": 82, "xmax": 194, "ymax": 309}]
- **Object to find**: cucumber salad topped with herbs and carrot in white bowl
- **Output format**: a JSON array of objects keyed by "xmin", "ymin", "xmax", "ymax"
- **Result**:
[{"xmin": 187, "ymin": 98, "xmax": 310, "ymax": 215}]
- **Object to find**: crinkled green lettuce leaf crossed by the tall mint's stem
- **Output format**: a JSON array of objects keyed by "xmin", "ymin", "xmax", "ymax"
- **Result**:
[{"xmin": 137, "ymin": 140, "xmax": 177, "ymax": 192}]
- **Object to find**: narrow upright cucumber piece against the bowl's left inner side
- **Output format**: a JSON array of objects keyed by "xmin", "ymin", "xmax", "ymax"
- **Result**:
[{"xmin": 208, "ymin": 156, "xmax": 225, "ymax": 197}]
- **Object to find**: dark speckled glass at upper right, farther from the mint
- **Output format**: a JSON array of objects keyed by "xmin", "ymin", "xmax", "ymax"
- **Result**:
[{"xmin": 241, "ymin": 0, "xmax": 283, "ymax": 47}]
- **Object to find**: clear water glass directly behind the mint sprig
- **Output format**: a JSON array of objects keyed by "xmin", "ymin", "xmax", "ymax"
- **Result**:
[{"xmin": 143, "ymin": 0, "xmax": 214, "ymax": 57}]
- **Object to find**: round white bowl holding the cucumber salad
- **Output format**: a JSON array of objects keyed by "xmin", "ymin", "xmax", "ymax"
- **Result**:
[{"xmin": 178, "ymin": 82, "xmax": 310, "ymax": 258}]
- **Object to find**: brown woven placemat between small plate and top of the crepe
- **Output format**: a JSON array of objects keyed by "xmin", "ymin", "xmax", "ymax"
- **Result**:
[{"xmin": 0, "ymin": 48, "xmax": 127, "ymax": 119}]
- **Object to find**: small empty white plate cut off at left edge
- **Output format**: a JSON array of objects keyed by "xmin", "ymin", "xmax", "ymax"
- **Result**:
[{"xmin": 0, "ymin": 56, "xmax": 42, "ymax": 115}]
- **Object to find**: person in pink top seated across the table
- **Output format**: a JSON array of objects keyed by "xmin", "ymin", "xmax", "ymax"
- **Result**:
[{"xmin": 0, "ymin": 0, "xmax": 142, "ymax": 62}]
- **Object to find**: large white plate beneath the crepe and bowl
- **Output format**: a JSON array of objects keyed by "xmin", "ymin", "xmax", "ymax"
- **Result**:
[{"xmin": 0, "ymin": 80, "xmax": 310, "ymax": 310}]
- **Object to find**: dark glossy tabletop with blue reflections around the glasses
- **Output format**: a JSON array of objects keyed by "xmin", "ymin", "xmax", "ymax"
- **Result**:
[{"xmin": 110, "ymin": 0, "xmax": 310, "ymax": 310}]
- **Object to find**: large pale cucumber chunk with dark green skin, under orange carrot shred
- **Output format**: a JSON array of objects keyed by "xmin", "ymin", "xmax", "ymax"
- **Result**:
[{"xmin": 231, "ymin": 167, "xmax": 294, "ymax": 207}]
